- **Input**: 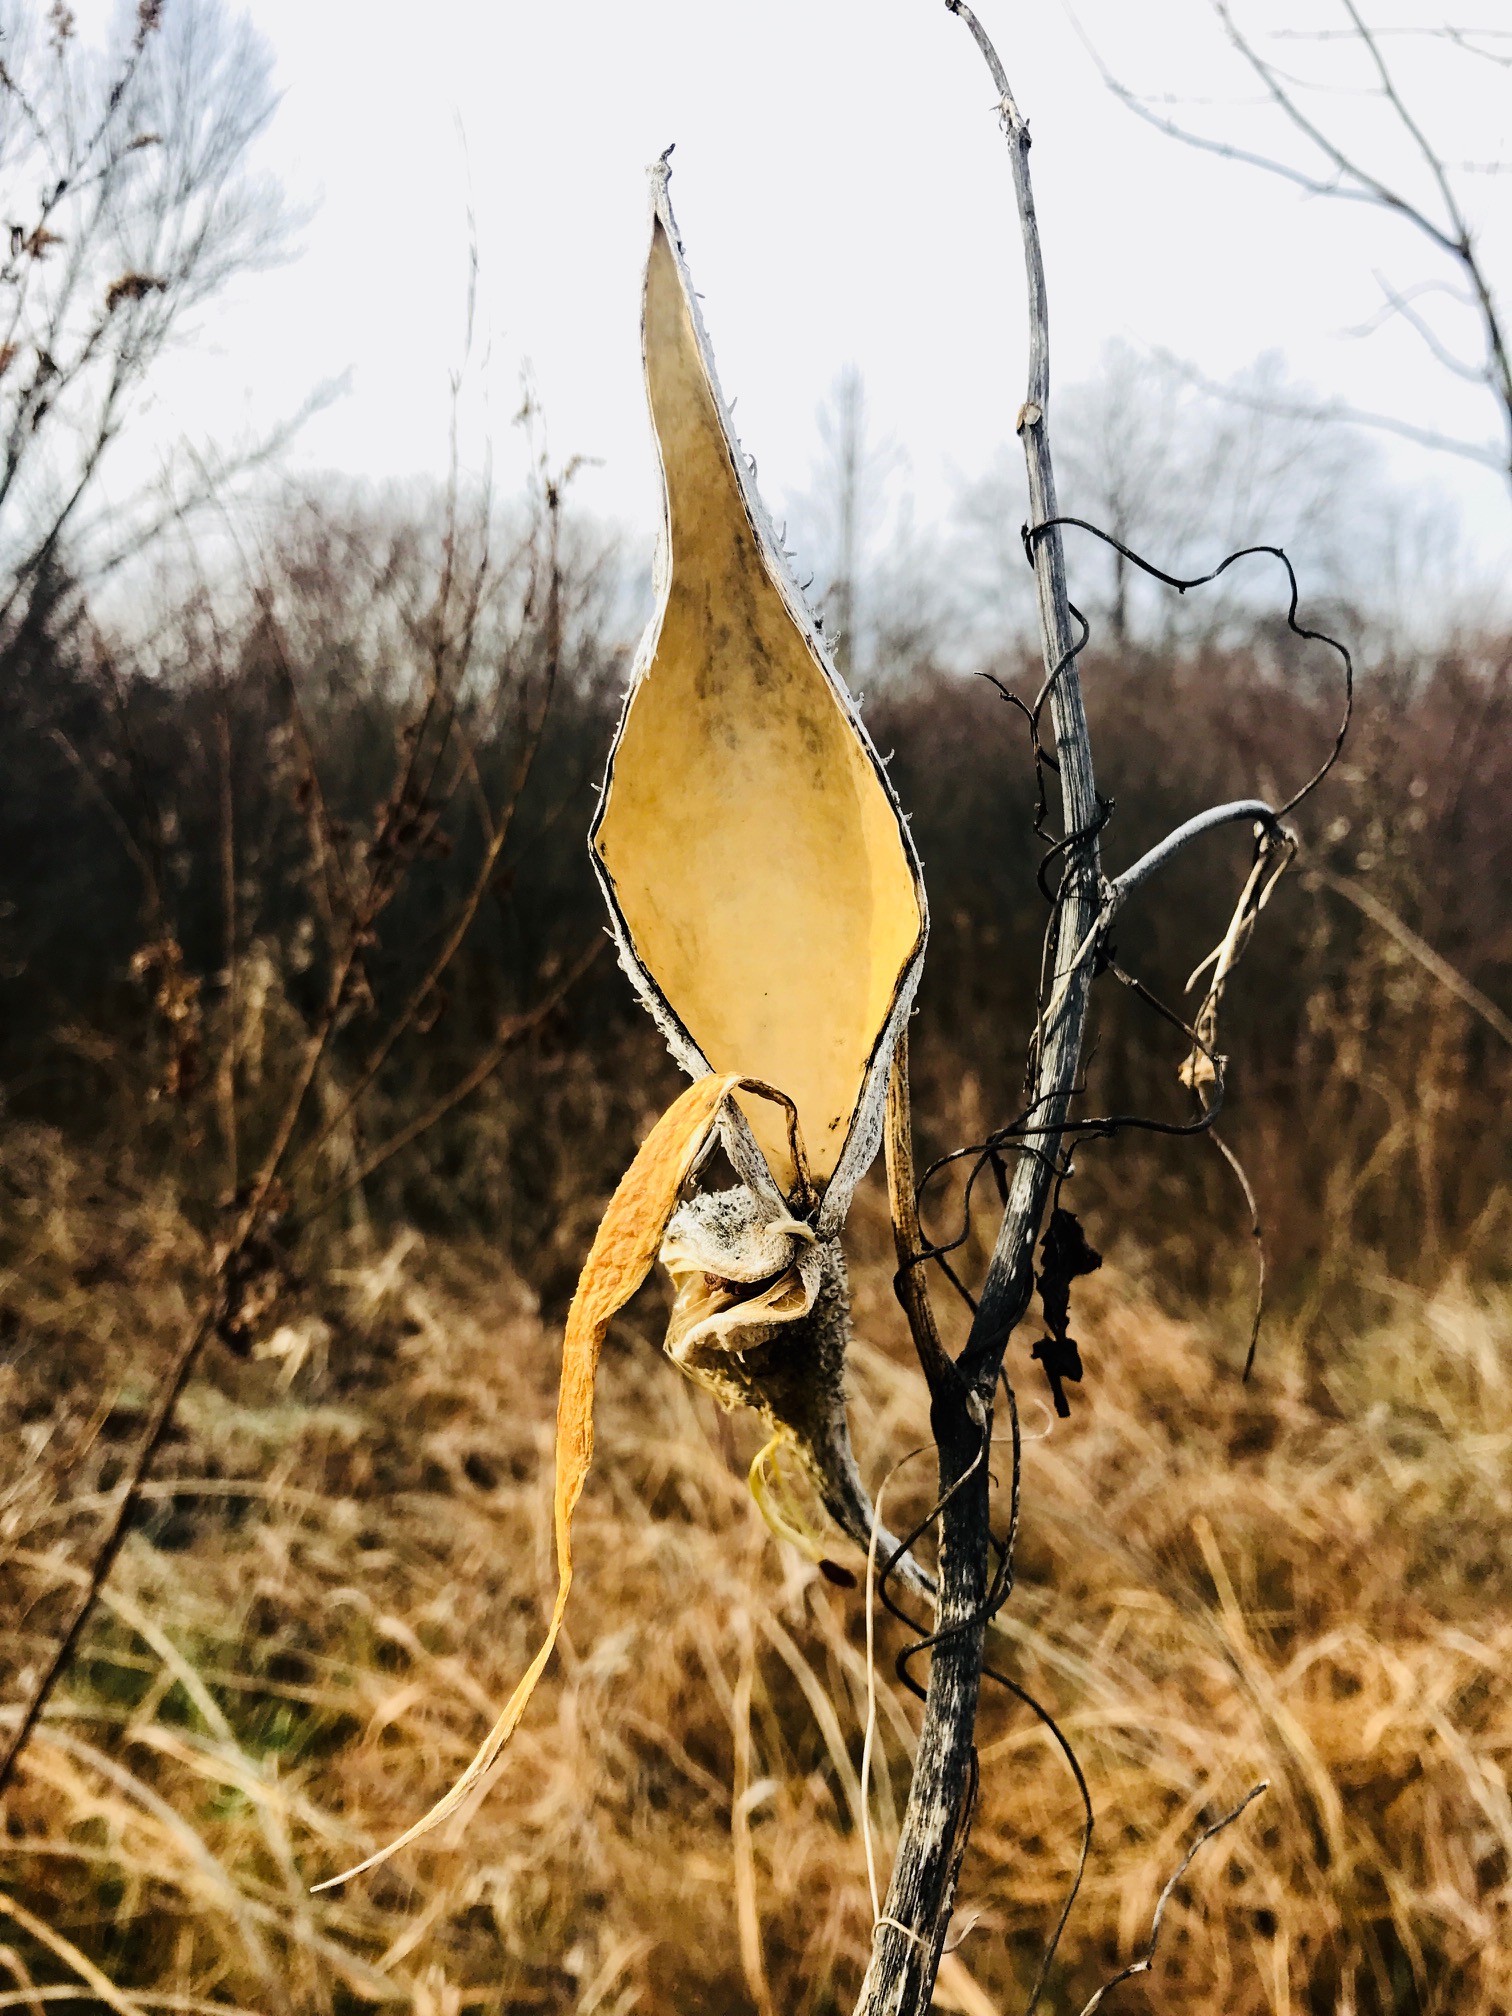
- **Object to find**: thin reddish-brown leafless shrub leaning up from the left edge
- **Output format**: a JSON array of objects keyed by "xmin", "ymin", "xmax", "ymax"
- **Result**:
[{"xmin": 0, "ymin": 389, "xmax": 603, "ymax": 1792}]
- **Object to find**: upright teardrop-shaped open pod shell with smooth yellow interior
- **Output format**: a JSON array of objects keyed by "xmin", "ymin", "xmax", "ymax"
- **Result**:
[{"xmin": 591, "ymin": 169, "xmax": 927, "ymax": 1236}]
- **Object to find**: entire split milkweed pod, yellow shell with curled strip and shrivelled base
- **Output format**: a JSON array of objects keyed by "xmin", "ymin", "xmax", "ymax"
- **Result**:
[{"xmin": 322, "ymin": 167, "xmax": 925, "ymax": 1883}]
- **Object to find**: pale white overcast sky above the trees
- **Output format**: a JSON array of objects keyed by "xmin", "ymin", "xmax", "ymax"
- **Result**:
[{"xmin": 145, "ymin": 0, "xmax": 1512, "ymax": 580}]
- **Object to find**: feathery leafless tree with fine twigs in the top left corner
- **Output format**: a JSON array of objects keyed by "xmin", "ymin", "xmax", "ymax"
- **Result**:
[{"xmin": 0, "ymin": 0, "xmax": 292, "ymax": 637}]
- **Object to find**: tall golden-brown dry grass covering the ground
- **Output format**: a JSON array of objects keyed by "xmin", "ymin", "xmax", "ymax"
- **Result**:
[{"xmin": 0, "ymin": 1129, "xmax": 1512, "ymax": 2016}]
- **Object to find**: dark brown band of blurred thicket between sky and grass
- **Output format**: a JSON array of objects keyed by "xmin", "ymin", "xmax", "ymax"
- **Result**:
[{"xmin": 0, "ymin": 500, "xmax": 1512, "ymax": 1308}]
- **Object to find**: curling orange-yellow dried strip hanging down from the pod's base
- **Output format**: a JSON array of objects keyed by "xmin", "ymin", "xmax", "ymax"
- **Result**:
[{"xmin": 314, "ymin": 1075, "xmax": 742, "ymax": 1889}]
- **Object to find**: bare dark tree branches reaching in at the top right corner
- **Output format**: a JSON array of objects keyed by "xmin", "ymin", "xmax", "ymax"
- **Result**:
[{"xmin": 1103, "ymin": 0, "xmax": 1512, "ymax": 499}]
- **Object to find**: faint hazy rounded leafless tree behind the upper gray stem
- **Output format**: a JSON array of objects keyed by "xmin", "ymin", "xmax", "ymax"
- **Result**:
[{"xmin": 960, "ymin": 343, "xmax": 1462, "ymax": 651}]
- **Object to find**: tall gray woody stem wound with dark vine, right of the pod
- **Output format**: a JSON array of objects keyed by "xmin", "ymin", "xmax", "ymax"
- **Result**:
[{"xmin": 857, "ymin": 0, "xmax": 1103, "ymax": 2016}]
